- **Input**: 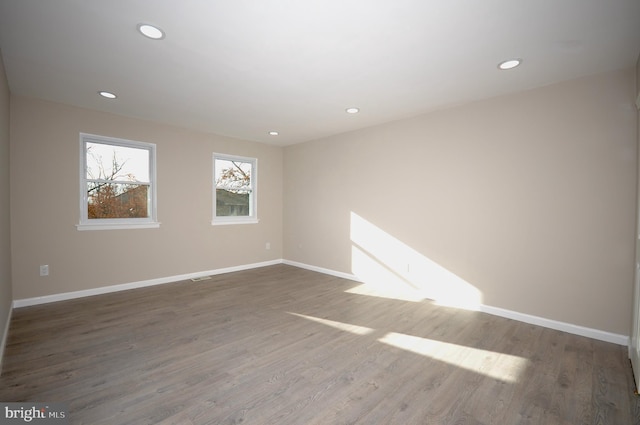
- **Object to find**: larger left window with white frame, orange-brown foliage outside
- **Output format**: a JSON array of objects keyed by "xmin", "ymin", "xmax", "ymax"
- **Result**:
[{"xmin": 78, "ymin": 133, "xmax": 159, "ymax": 230}]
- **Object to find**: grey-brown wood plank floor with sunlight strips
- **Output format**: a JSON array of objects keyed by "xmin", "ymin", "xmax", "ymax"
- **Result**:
[{"xmin": 0, "ymin": 265, "xmax": 640, "ymax": 425}]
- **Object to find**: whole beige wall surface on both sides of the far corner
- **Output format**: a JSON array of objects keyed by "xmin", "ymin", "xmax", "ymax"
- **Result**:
[{"xmin": 6, "ymin": 64, "xmax": 637, "ymax": 335}]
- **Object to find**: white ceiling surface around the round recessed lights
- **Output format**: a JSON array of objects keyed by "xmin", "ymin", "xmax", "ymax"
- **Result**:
[{"xmin": 0, "ymin": 0, "xmax": 640, "ymax": 145}]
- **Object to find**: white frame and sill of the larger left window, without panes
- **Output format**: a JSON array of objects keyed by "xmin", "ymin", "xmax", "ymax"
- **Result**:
[{"xmin": 76, "ymin": 133, "xmax": 160, "ymax": 230}]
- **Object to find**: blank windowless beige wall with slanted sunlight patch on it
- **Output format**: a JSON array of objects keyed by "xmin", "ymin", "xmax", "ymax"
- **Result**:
[{"xmin": 284, "ymin": 69, "xmax": 637, "ymax": 335}]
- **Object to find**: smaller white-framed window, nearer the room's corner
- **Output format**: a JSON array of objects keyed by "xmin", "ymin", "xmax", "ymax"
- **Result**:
[{"xmin": 212, "ymin": 153, "xmax": 258, "ymax": 224}]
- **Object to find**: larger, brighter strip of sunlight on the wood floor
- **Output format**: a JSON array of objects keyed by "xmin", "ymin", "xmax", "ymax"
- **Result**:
[{"xmin": 378, "ymin": 332, "xmax": 529, "ymax": 383}]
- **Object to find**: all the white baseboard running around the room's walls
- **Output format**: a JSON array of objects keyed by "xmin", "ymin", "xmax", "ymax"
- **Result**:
[{"xmin": 10, "ymin": 259, "xmax": 629, "ymax": 346}]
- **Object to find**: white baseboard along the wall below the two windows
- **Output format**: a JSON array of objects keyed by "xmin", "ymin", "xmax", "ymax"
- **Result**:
[{"xmin": 13, "ymin": 260, "xmax": 282, "ymax": 308}]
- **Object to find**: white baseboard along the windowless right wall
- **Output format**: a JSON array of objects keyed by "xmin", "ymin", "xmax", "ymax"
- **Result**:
[{"xmin": 283, "ymin": 260, "xmax": 629, "ymax": 346}]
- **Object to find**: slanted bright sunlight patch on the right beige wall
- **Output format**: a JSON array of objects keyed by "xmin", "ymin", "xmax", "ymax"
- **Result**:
[{"xmin": 348, "ymin": 212, "xmax": 482, "ymax": 310}]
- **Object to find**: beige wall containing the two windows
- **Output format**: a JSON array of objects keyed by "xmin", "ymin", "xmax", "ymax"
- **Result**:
[{"xmin": 11, "ymin": 96, "xmax": 283, "ymax": 299}]
